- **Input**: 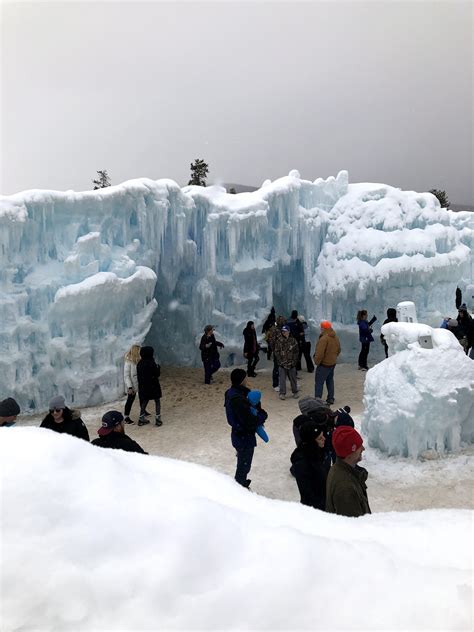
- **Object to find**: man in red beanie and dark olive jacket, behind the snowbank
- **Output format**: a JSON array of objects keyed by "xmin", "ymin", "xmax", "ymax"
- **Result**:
[{"xmin": 326, "ymin": 426, "xmax": 371, "ymax": 518}]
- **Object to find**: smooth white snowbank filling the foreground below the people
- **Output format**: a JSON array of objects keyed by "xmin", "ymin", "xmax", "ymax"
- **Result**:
[{"xmin": 0, "ymin": 428, "xmax": 473, "ymax": 632}]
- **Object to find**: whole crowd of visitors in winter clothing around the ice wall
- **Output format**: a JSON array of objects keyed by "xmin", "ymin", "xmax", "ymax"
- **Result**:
[{"xmin": 0, "ymin": 296, "xmax": 474, "ymax": 517}]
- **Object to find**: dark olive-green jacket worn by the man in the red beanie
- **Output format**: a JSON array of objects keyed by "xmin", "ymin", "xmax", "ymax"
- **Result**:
[{"xmin": 326, "ymin": 458, "xmax": 372, "ymax": 517}]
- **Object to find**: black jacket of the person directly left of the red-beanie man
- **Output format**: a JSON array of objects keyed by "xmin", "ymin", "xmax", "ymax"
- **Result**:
[{"xmin": 290, "ymin": 443, "xmax": 327, "ymax": 511}]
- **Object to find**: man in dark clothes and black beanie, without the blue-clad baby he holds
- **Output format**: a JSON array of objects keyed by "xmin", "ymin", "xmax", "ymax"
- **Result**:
[{"xmin": 224, "ymin": 369, "xmax": 267, "ymax": 489}]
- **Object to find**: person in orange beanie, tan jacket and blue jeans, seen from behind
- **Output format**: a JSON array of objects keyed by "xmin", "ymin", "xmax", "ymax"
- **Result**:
[{"xmin": 314, "ymin": 320, "xmax": 341, "ymax": 406}]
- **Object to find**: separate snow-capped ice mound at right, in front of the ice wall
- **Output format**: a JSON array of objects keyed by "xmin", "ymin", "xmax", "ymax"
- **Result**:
[{"xmin": 362, "ymin": 323, "xmax": 474, "ymax": 457}]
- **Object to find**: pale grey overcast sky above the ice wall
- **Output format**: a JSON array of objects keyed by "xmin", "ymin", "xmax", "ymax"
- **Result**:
[{"xmin": 0, "ymin": 0, "xmax": 474, "ymax": 204}]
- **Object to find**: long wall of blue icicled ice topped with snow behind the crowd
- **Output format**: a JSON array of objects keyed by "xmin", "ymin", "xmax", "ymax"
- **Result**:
[{"xmin": 0, "ymin": 171, "xmax": 474, "ymax": 409}]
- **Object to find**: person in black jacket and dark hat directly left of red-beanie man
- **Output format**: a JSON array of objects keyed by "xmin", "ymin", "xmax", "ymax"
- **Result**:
[{"xmin": 290, "ymin": 419, "xmax": 328, "ymax": 511}]
